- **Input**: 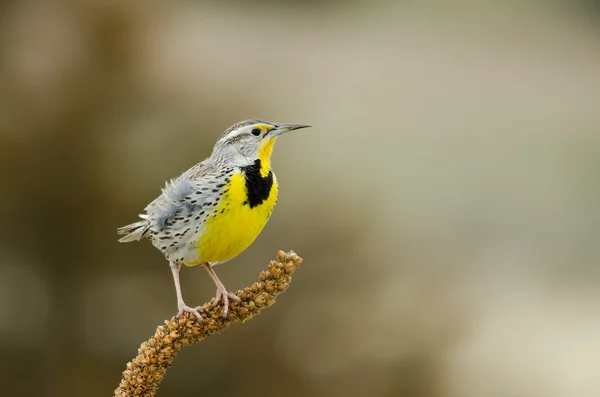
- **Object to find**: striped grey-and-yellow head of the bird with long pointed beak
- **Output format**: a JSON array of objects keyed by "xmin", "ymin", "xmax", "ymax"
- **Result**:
[{"xmin": 213, "ymin": 119, "xmax": 310, "ymax": 173}]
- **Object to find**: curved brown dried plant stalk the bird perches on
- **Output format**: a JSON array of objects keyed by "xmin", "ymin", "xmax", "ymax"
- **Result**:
[{"xmin": 114, "ymin": 251, "xmax": 302, "ymax": 397}]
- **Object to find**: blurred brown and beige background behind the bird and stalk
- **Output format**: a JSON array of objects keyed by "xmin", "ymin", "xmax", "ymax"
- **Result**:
[{"xmin": 0, "ymin": 0, "xmax": 600, "ymax": 397}]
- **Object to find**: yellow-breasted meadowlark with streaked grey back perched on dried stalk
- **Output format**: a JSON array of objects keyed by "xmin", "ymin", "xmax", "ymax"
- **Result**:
[{"xmin": 117, "ymin": 119, "xmax": 311, "ymax": 322}]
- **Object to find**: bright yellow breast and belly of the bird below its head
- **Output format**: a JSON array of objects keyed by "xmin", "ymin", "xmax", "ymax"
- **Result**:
[{"xmin": 190, "ymin": 169, "xmax": 279, "ymax": 265}]
